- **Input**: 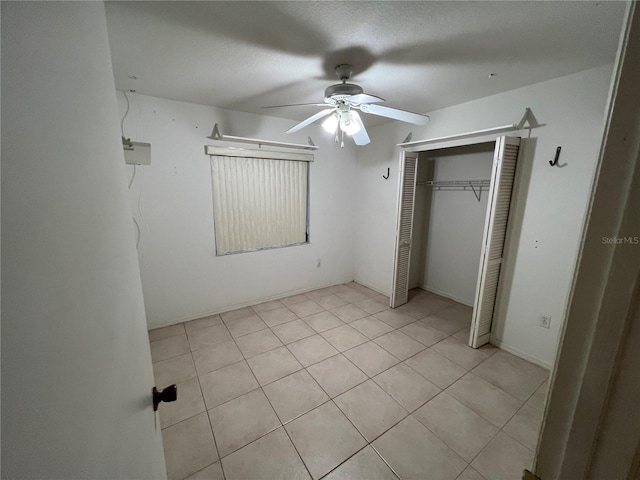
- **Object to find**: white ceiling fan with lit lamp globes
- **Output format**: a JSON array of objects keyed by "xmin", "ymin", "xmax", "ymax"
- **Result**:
[{"xmin": 264, "ymin": 64, "xmax": 429, "ymax": 147}]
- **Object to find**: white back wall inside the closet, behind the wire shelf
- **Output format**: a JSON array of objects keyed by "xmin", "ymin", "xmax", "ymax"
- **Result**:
[{"xmin": 420, "ymin": 149, "xmax": 493, "ymax": 306}]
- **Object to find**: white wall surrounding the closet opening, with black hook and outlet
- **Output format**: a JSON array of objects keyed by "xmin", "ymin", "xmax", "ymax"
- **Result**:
[{"xmin": 355, "ymin": 65, "xmax": 612, "ymax": 366}]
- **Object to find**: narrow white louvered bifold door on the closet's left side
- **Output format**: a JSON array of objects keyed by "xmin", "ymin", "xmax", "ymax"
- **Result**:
[{"xmin": 391, "ymin": 152, "xmax": 418, "ymax": 308}]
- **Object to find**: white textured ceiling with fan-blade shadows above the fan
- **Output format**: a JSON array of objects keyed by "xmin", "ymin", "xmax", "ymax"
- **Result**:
[{"xmin": 106, "ymin": 1, "xmax": 625, "ymax": 125}]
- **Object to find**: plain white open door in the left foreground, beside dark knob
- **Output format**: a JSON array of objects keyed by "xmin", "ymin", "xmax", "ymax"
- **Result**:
[{"xmin": 2, "ymin": 2, "xmax": 166, "ymax": 479}]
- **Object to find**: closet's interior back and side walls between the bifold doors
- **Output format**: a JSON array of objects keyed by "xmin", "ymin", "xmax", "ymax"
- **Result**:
[{"xmin": 409, "ymin": 142, "xmax": 495, "ymax": 306}]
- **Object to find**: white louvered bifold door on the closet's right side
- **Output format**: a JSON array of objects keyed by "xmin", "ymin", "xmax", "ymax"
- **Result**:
[{"xmin": 469, "ymin": 137, "xmax": 520, "ymax": 348}]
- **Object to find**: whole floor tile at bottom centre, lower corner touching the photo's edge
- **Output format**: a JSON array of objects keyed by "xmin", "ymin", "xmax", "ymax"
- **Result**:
[{"xmin": 285, "ymin": 402, "xmax": 367, "ymax": 479}]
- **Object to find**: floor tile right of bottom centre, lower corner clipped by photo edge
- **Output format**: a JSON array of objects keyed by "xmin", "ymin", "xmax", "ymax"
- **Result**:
[{"xmin": 372, "ymin": 416, "xmax": 467, "ymax": 480}]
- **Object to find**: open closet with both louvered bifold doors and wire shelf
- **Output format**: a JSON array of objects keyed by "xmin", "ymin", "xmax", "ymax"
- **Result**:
[{"xmin": 391, "ymin": 136, "xmax": 520, "ymax": 348}]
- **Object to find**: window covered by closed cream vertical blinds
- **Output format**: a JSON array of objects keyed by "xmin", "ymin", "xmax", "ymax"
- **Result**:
[{"xmin": 207, "ymin": 147, "xmax": 313, "ymax": 255}]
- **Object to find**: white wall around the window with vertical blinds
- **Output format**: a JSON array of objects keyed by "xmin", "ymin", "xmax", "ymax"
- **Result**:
[{"xmin": 118, "ymin": 93, "xmax": 355, "ymax": 327}]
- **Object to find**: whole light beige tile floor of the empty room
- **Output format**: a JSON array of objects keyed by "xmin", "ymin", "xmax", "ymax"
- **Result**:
[{"xmin": 149, "ymin": 283, "xmax": 548, "ymax": 480}]
